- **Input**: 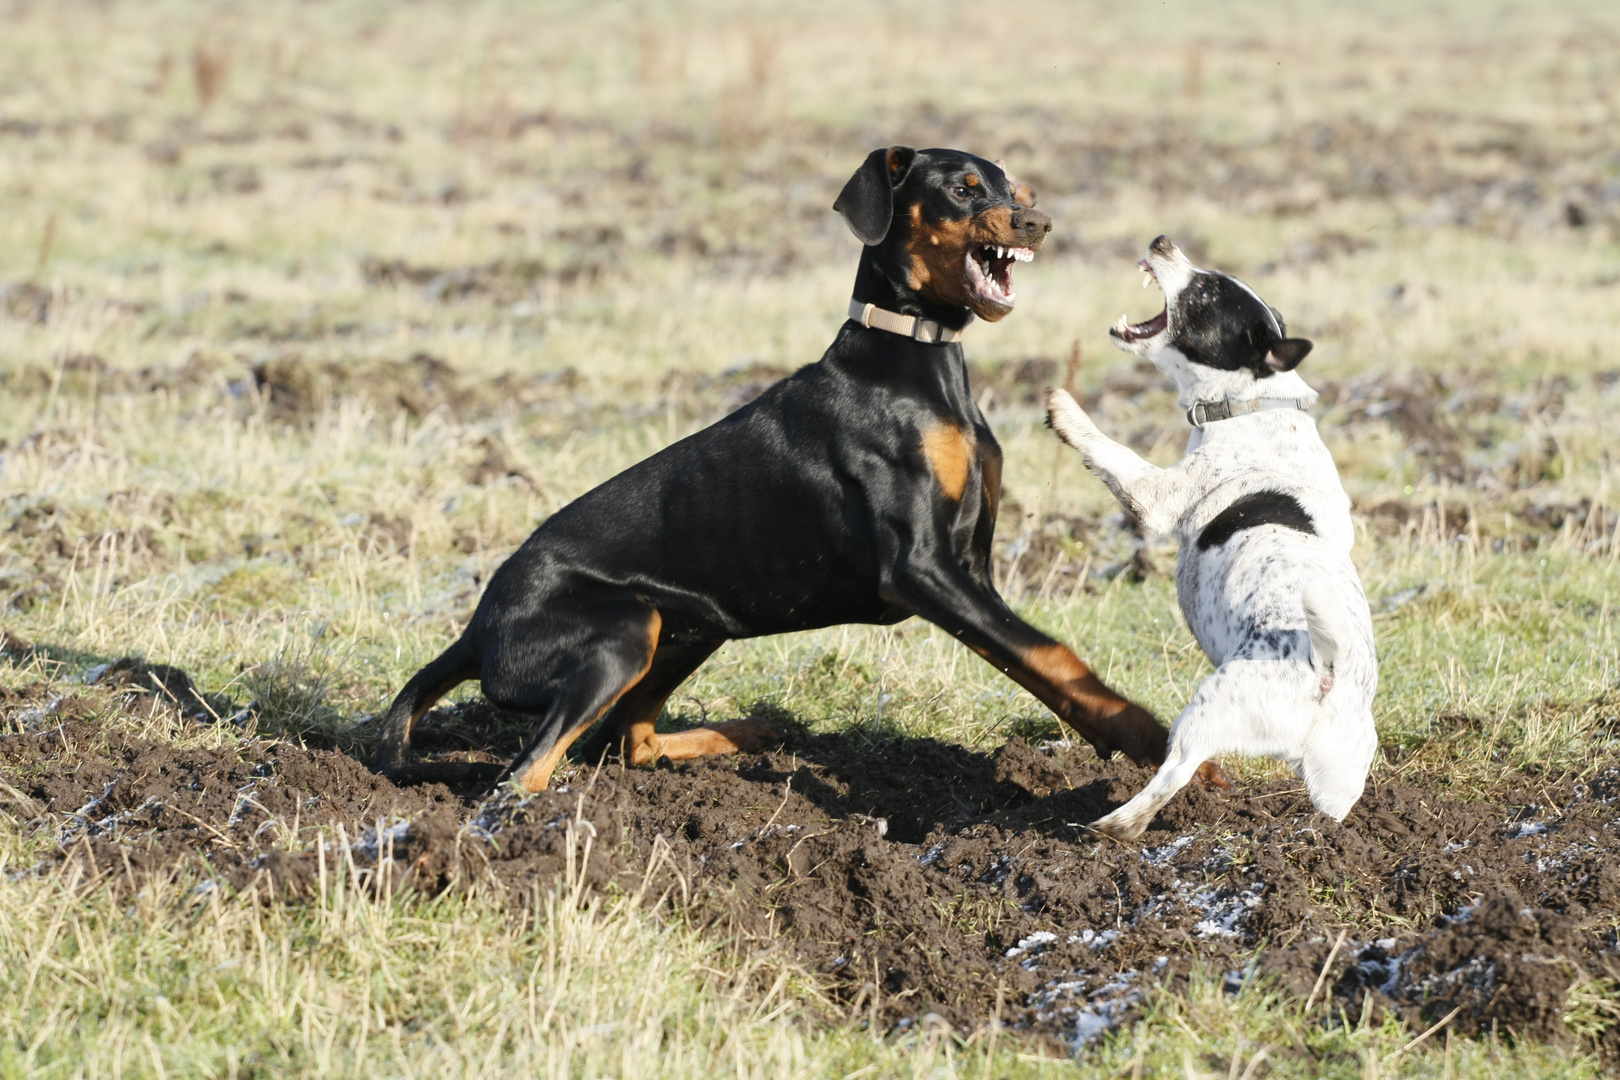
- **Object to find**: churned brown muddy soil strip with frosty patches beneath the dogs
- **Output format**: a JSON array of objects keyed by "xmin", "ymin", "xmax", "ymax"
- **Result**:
[{"xmin": 0, "ymin": 680, "xmax": 1620, "ymax": 1059}]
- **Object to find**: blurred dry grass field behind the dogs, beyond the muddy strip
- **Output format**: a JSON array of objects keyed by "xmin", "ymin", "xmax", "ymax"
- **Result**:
[{"xmin": 0, "ymin": 0, "xmax": 1620, "ymax": 1075}]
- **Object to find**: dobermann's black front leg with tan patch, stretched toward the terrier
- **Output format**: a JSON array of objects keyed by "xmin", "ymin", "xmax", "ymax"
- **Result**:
[{"xmin": 886, "ymin": 547, "xmax": 1168, "ymax": 764}]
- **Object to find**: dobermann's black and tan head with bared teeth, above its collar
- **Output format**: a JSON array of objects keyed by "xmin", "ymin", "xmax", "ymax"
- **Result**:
[{"xmin": 833, "ymin": 146, "xmax": 1051, "ymax": 329}]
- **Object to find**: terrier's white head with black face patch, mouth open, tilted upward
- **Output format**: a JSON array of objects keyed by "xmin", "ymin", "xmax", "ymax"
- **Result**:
[{"xmin": 1108, "ymin": 236, "xmax": 1315, "ymax": 405}]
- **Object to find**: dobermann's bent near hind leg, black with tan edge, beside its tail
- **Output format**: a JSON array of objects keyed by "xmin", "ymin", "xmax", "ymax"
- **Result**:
[{"xmin": 495, "ymin": 604, "xmax": 661, "ymax": 792}]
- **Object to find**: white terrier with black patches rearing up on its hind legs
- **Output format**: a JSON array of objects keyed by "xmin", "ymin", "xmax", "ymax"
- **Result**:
[{"xmin": 1047, "ymin": 236, "xmax": 1379, "ymax": 839}]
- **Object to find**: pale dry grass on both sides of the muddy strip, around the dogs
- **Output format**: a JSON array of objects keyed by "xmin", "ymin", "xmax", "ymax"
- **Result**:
[{"xmin": 0, "ymin": 0, "xmax": 1620, "ymax": 1078}]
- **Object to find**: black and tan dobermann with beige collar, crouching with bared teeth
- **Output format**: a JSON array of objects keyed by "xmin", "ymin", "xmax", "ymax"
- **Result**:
[{"xmin": 376, "ymin": 146, "xmax": 1198, "ymax": 790}]
